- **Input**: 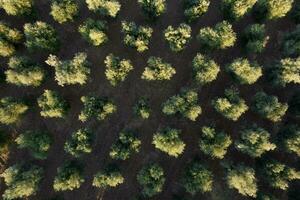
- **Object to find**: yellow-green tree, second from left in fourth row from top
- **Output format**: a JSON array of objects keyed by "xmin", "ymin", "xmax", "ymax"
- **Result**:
[{"xmin": 37, "ymin": 90, "xmax": 69, "ymax": 118}]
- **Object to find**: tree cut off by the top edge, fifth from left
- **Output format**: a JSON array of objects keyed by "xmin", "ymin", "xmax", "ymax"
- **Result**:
[{"xmin": 184, "ymin": 0, "xmax": 210, "ymax": 22}]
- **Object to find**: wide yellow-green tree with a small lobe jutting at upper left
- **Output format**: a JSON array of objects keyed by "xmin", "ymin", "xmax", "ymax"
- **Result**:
[{"xmin": 45, "ymin": 52, "xmax": 91, "ymax": 86}]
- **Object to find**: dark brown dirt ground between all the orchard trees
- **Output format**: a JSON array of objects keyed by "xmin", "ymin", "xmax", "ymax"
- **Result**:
[{"xmin": 0, "ymin": 0, "xmax": 300, "ymax": 200}]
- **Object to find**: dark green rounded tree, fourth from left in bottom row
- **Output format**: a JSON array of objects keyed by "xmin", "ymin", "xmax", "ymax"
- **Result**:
[{"xmin": 137, "ymin": 163, "xmax": 166, "ymax": 198}]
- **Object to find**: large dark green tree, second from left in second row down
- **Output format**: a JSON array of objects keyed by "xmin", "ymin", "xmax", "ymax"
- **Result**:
[{"xmin": 24, "ymin": 21, "xmax": 60, "ymax": 52}]
